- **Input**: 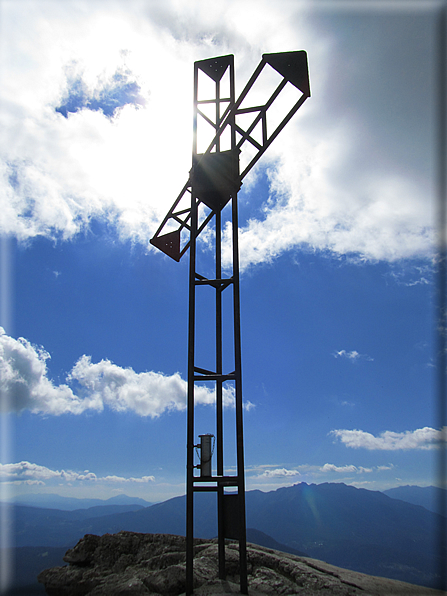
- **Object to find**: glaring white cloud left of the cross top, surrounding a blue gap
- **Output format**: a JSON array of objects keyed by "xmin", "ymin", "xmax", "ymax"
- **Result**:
[{"xmin": 0, "ymin": 1, "xmax": 294, "ymax": 244}]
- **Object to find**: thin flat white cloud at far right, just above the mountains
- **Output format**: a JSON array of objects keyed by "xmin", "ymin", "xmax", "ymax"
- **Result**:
[{"xmin": 329, "ymin": 426, "xmax": 447, "ymax": 451}]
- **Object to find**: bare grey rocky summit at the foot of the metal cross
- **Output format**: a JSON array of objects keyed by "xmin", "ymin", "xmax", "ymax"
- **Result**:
[{"xmin": 38, "ymin": 531, "xmax": 439, "ymax": 596}]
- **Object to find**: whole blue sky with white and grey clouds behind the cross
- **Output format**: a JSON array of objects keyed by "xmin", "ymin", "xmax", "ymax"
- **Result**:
[{"xmin": 0, "ymin": 0, "xmax": 441, "ymax": 501}]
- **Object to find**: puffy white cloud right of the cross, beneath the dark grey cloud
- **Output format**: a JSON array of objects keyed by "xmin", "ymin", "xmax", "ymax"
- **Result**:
[{"xmin": 229, "ymin": 137, "xmax": 434, "ymax": 268}]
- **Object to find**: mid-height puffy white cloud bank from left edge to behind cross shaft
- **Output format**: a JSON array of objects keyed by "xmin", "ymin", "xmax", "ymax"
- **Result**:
[{"xmin": 0, "ymin": 328, "xmax": 253, "ymax": 418}]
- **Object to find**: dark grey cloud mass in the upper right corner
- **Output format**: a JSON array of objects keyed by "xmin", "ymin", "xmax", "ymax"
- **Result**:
[{"xmin": 309, "ymin": 10, "xmax": 436, "ymax": 180}]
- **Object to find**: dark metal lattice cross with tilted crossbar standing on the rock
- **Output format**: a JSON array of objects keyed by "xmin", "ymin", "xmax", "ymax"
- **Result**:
[{"xmin": 151, "ymin": 51, "xmax": 310, "ymax": 596}]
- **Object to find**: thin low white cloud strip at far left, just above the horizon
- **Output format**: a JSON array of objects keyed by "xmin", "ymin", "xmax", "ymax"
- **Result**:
[{"xmin": 0, "ymin": 461, "xmax": 155, "ymax": 485}]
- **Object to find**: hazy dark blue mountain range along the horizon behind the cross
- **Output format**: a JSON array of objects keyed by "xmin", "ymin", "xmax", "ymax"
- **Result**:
[{"xmin": 2, "ymin": 483, "xmax": 446, "ymax": 587}]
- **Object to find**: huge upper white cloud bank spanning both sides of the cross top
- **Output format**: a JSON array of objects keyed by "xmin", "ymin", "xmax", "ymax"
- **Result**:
[{"xmin": 0, "ymin": 0, "xmax": 433, "ymax": 268}]
